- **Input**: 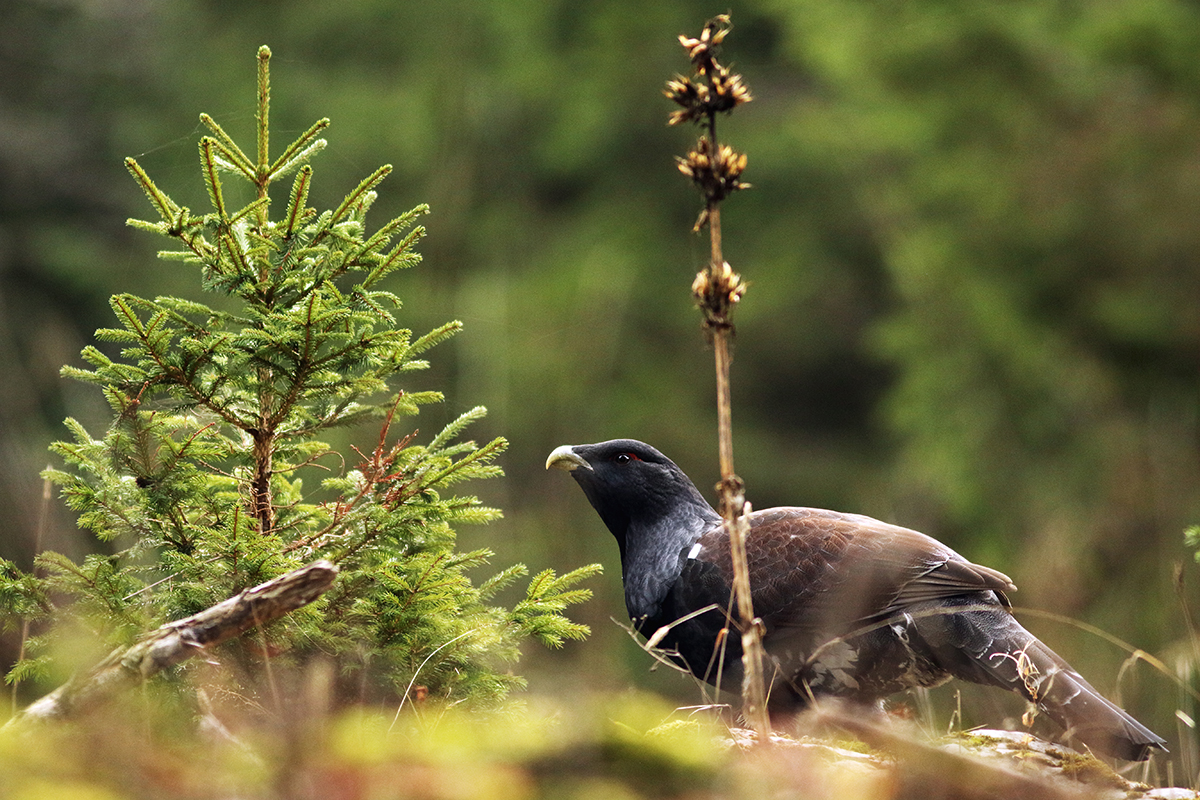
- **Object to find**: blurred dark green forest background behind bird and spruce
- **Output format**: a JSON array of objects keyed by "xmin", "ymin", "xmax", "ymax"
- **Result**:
[{"xmin": 0, "ymin": 0, "xmax": 1200, "ymax": 753}]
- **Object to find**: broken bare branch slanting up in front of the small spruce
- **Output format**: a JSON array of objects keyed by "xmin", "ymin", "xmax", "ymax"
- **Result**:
[{"xmin": 5, "ymin": 560, "xmax": 337, "ymax": 728}]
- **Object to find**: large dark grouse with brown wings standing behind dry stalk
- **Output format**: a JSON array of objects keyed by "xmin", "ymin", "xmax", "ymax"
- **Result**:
[{"xmin": 546, "ymin": 439, "xmax": 1165, "ymax": 760}]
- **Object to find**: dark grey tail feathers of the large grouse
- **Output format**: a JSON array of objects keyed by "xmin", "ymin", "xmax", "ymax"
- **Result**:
[{"xmin": 926, "ymin": 609, "xmax": 1166, "ymax": 760}]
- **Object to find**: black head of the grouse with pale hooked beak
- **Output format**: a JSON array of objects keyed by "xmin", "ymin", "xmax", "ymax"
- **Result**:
[{"xmin": 546, "ymin": 439, "xmax": 719, "ymax": 553}]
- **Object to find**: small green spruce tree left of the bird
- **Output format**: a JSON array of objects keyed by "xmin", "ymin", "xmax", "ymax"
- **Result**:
[{"xmin": 0, "ymin": 47, "xmax": 599, "ymax": 704}]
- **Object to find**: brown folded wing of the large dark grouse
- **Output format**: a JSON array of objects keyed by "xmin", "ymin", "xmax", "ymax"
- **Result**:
[{"xmin": 694, "ymin": 507, "xmax": 1015, "ymax": 631}]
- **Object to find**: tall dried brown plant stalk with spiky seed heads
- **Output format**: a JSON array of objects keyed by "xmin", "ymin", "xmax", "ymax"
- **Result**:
[{"xmin": 664, "ymin": 14, "xmax": 770, "ymax": 742}]
